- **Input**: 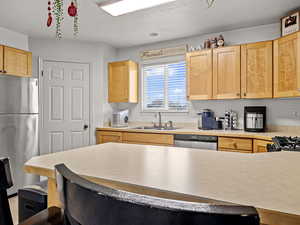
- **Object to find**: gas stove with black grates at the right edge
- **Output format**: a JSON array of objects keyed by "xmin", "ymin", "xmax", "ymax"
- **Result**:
[{"xmin": 267, "ymin": 136, "xmax": 300, "ymax": 152}]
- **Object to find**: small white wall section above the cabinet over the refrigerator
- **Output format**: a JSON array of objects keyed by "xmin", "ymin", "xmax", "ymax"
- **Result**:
[{"xmin": 0, "ymin": 27, "xmax": 28, "ymax": 51}]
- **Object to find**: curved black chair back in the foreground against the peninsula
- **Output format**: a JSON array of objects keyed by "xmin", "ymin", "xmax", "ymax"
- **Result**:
[{"xmin": 55, "ymin": 164, "xmax": 259, "ymax": 225}]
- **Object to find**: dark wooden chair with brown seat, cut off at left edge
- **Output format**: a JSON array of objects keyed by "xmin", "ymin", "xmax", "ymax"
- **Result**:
[{"xmin": 0, "ymin": 158, "xmax": 63, "ymax": 225}]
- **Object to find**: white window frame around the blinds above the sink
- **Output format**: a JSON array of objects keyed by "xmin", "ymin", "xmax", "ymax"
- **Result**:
[{"xmin": 141, "ymin": 59, "xmax": 189, "ymax": 113}]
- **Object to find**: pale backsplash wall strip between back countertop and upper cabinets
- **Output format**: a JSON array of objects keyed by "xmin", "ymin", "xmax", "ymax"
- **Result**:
[{"xmin": 115, "ymin": 98, "xmax": 300, "ymax": 128}]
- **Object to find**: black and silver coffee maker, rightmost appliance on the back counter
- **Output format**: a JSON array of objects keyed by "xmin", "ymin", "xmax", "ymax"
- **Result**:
[{"xmin": 244, "ymin": 106, "xmax": 267, "ymax": 132}]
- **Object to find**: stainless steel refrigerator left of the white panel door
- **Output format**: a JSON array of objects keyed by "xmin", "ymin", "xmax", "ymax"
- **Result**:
[{"xmin": 0, "ymin": 75, "xmax": 39, "ymax": 195}]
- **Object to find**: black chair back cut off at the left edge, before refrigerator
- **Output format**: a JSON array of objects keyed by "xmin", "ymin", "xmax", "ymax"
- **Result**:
[{"xmin": 0, "ymin": 158, "xmax": 13, "ymax": 225}]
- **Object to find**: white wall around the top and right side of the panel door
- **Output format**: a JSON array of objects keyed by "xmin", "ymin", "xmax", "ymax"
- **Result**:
[{"xmin": 29, "ymin": 38, "xmax": 116, "ymax": 144}]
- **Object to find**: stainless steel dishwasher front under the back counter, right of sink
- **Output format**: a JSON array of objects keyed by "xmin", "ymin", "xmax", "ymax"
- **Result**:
[{"xmin": 174, "ymin": 134, "xmax": 218, "ymax": 151}]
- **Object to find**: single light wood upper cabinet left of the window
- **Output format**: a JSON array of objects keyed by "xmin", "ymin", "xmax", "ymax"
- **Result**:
[{"xmin": 108, "ymin": 60, "xmax": 138, "ymax": 103}]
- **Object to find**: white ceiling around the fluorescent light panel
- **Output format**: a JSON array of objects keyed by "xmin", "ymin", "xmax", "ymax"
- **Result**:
[{"xmin": 0, "ymin": 0, "xmax": 300, "ymax": 47}]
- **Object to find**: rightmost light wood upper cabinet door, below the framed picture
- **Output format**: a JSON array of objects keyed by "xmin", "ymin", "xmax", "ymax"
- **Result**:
[{"xmin": 274, "ymin": 32, "xmax": 300, "ymax": 98}]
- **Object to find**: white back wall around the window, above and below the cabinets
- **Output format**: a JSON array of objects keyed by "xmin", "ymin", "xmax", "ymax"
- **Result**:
[{"xmin": 117, "ymin": 23, "xmax": 300, "ymax": 127}]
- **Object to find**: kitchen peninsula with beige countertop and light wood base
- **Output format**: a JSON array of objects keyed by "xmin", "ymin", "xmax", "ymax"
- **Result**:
[{"xmin": 25, "ymin": 143, "xmax": 300, "ymax": 225}]
